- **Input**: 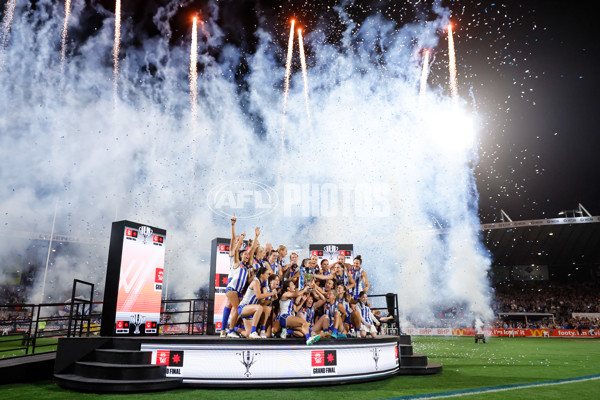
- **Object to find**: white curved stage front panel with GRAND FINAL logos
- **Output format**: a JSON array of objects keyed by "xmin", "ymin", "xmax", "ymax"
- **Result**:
[{"xmin": 141, "ymin": 341, "xmax": 399, "ymax": 384}]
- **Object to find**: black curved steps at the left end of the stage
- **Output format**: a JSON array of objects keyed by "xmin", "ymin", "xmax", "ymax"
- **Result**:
[{"xmin": 54, "ymin": 340, "xmax": 182, "ymax": 393}]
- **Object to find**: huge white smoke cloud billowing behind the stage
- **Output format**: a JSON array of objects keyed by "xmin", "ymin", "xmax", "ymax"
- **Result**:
[{"xmin": 0, "ymin": 0, "xmax": 491, "ymax": 321}]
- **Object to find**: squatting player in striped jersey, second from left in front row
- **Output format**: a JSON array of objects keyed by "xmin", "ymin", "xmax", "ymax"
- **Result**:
[{"xmin": 238, "ymin": 267, "xmax": 272, "ymax": 339}]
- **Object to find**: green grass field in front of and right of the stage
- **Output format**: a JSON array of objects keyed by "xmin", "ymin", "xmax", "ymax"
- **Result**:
[{"xmin": 0, "ymin": 337, "xmax": 600, "ymax": 400}]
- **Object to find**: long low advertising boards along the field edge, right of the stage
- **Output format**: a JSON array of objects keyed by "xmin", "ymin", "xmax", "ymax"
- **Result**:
[{"xmin": 402, "ymin": 328, "xmax": 600, "ymax": 338}]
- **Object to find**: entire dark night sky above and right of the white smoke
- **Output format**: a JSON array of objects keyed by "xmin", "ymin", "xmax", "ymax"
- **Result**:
[{"xmin": 102, "ymin": 0, "xmax": 600, "ymax": 222}]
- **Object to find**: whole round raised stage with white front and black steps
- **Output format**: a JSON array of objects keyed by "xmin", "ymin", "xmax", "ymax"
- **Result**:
[{"xmin": 54, "ymin": 335, "xmax": 442, "ymax": 393}]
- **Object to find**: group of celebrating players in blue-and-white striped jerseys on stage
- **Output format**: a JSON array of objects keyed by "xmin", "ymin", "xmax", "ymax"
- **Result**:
[{"xmin": 221, "ymin": 216, "xmax": 380, "ymax": 345}]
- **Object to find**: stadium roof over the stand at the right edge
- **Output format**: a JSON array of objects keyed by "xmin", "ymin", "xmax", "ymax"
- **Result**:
[{"xmin": 481, "ymin": 216, "xmax": 600, "ymax": 266}]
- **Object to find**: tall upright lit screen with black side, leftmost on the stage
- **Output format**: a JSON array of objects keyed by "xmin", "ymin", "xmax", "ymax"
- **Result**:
[{"xmin": 101, "ymin": 221, "xmax": 167, "ymax": 336}]
